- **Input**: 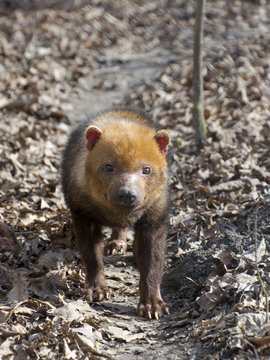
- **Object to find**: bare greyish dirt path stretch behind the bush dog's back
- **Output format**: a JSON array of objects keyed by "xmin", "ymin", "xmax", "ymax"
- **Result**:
[{"xmin": 68, "ymin": 48, "xmax": 176, "ymax": 122}]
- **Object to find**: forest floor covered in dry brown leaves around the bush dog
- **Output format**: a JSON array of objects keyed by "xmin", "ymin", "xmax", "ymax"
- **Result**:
[{"xmin": 0, "ymin": 0, "xmax": 270, "ymax": 360}]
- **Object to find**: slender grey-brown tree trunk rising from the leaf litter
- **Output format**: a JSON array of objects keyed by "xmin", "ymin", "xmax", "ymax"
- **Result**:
[{"xmin": 193, "ymin": 0, "xmax": 207, "ymax": 147}]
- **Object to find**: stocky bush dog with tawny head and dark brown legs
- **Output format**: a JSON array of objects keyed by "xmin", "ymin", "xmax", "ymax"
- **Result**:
[{"xmin": 62, "ymin": 108, "xmax": 169, "ymax": 319}]
